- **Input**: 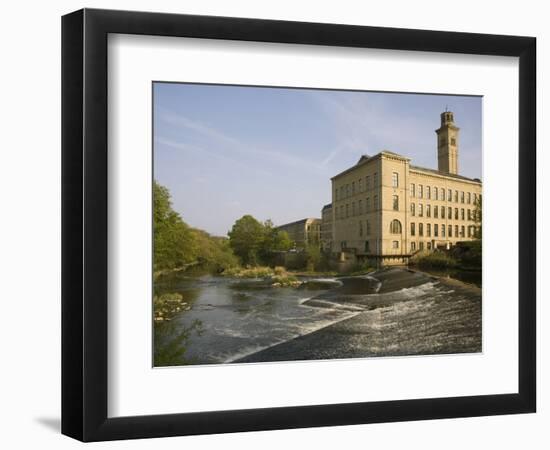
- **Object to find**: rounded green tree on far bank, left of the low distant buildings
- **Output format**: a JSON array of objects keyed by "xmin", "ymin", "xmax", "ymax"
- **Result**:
[{"xmin": 227, "ymin": 214, "xmax": 265, "ymax": 265}]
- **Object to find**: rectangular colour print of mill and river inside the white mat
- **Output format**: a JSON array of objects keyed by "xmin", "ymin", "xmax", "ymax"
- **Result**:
[{"xmin": 152, "ymin": 82, "xmax": 483, "ymax": 367}]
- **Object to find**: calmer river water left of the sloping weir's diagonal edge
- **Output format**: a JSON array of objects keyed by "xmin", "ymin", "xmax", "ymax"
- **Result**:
[{"xmin": 155, "ymin": 274, "xmax": 352, "ymax": 366}]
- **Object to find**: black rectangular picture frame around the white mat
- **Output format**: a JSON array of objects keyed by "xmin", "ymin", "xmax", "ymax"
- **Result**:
[{"xmin": 62, "ymin": 9, "xmax": 536, "ymax": 441}]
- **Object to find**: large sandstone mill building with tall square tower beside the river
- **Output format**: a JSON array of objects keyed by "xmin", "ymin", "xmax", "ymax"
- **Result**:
[{"xmin": 331, "ymin": 111, "xmax": 482, "ymax": 264}]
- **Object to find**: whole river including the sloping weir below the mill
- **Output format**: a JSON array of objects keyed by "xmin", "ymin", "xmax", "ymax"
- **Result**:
[{"xmin": 155, "ymin": 269, "xmax": 481, "ymax": 365}]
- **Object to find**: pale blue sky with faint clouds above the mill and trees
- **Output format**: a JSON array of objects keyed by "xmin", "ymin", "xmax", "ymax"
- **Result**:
[{"xmin": 153, "ymin": 83, "xmax": 482, "ymax": 236}]
